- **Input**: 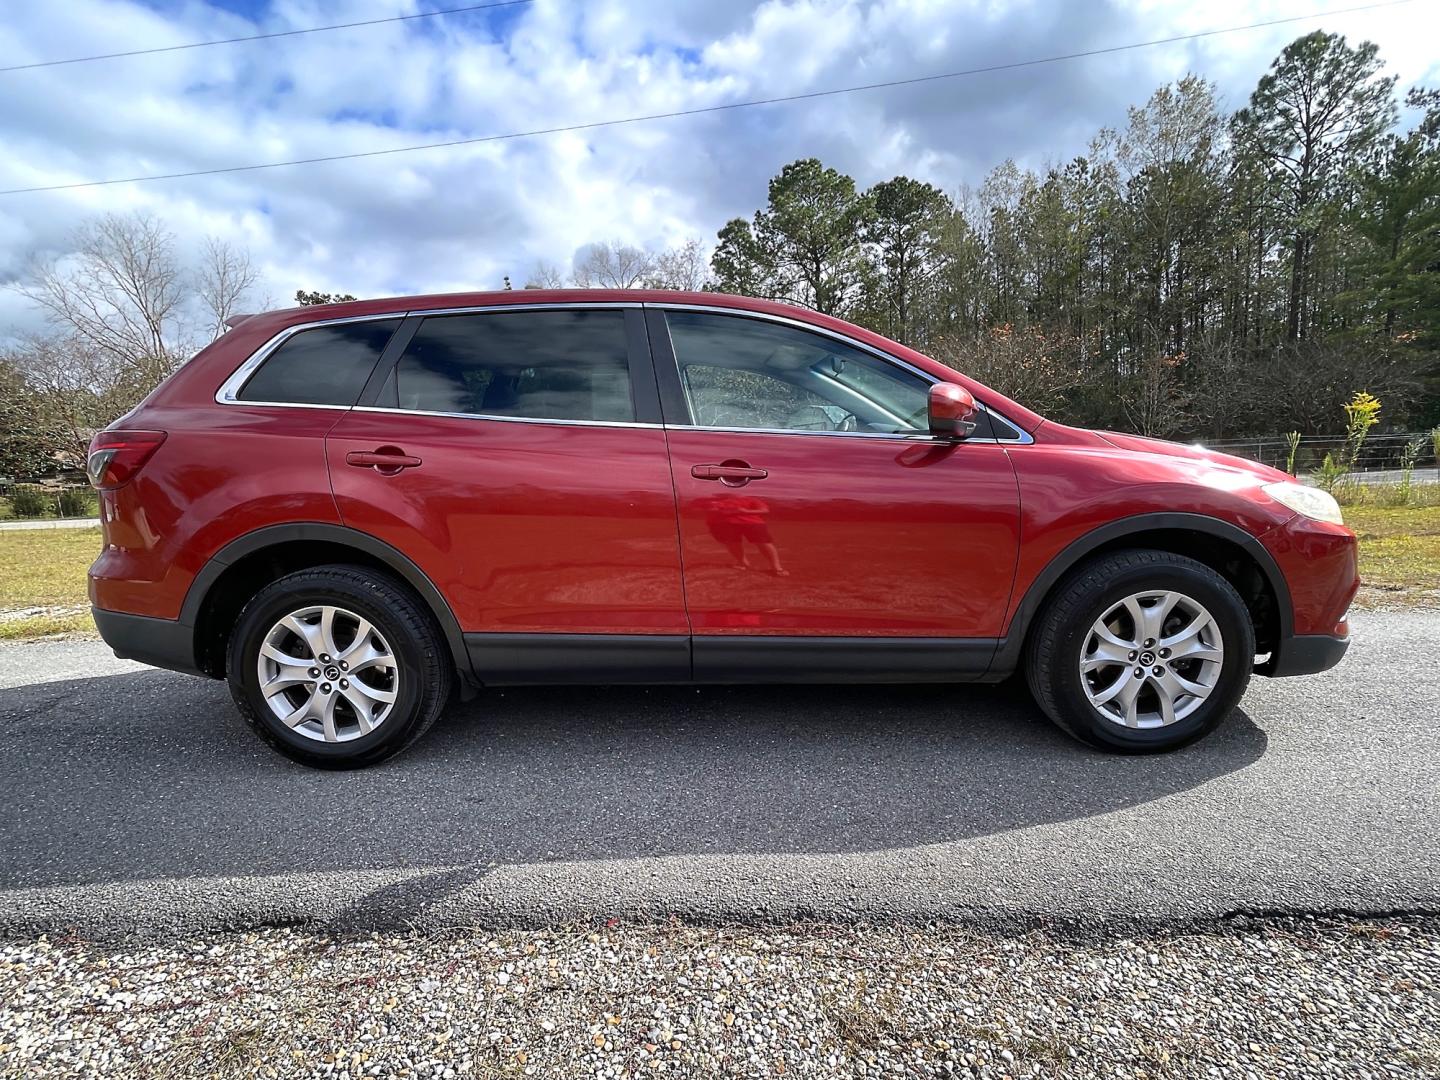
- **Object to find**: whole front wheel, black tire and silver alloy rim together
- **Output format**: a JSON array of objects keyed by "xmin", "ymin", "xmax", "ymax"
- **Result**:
[{"xmin": 1025, "ymin": 552, "xmax": 1254, "ymax": 753}]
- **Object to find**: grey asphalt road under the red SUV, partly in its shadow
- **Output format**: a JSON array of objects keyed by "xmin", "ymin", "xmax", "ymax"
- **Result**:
[{"xmin": 0, "ymin": 612, "xmax": 1440, "ymax": 937}]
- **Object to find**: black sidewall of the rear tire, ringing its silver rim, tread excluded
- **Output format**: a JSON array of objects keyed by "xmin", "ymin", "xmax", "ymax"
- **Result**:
[{"xmin": 228, "ymin": 580, "xmax": 425, "ymax": 768}]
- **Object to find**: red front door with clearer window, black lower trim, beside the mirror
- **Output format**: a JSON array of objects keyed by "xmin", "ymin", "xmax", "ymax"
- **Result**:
[{"xmin": 648, "ymin": 310, "xmax": 1020, "ymax": 680}]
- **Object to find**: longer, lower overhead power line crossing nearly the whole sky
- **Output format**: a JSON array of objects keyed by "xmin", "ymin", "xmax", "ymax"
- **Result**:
[{"xmin": 0, "ymin": 0, "xmax": 1413, "ymax": 196}]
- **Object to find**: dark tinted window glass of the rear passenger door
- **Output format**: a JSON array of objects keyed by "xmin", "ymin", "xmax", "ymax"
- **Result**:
[{"xmin": 397, "ymin": 310, "xmax": 635, "ymax": 422}]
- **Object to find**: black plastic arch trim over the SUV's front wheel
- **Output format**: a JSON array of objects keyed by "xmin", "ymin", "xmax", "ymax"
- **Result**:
[{"xmin": 989, "ymin": 511, "xmax": 1295, "ymax": 677}]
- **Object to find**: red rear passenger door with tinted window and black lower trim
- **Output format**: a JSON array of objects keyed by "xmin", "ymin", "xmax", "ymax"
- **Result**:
[{"xmin": 327, "ymin": 305, "xmax": 690, "ymax": 683}]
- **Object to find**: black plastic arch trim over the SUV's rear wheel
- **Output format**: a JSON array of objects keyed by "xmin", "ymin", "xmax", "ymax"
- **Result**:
[{"xmin": 180, "ymin": 521, "xmax": 474, "ymax": 683}]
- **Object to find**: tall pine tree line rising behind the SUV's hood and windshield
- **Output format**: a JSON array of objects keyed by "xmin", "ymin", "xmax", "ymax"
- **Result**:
[{"xmin": 711, "ymin": 33, "xmax": 1440, "ymax": 438}]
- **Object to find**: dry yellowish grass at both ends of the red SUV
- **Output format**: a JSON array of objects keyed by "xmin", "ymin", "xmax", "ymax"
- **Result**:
[{"xmin": 0, "ymin": 505, "xmax": 1440, "ymax": 641}]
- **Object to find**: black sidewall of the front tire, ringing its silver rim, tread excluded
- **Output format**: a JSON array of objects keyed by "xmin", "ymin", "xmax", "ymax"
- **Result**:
[{"xmin": 1050, "ymin": 563, "xmax": 1254, "ymax": 753}]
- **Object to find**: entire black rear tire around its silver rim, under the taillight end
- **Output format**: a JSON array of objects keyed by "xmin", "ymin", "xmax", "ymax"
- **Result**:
[{"xmin": 226, "ymin": 566, "xmax": 455, "ymax": 769}]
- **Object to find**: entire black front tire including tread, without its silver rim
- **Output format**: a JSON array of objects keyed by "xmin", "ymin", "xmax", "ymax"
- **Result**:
[{"xmin": 1025, "ymin": 550, "xmax": 1256, "ymax": 753}]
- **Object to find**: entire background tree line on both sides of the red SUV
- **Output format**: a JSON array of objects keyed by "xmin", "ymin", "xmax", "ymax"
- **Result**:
[{"xmin": 0, "ymin": 32, "xmax": 1440, "ymax": 475}]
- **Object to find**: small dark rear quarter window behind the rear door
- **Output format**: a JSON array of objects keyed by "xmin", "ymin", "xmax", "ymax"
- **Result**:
[{"xmin": 236, "ymin": 318, "xmax": 400, "ymax": 405}]
